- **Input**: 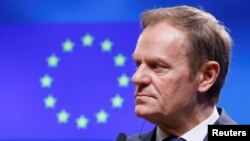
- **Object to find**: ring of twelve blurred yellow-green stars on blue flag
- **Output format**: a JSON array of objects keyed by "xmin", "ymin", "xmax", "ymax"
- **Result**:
[{"xmin": 40, "ymin": 33, "xmax": 130, "ymax": 129}]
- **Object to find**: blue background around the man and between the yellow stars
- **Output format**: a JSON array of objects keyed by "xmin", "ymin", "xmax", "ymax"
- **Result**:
[{"xmin": 0, "ymin": 0, "xmax": 250, "ymax": 140}]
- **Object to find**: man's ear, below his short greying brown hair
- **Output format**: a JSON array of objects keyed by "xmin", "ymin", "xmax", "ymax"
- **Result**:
[{"xmin": 198, "ymin": 61, "xmax": 220, "ymax": 93}]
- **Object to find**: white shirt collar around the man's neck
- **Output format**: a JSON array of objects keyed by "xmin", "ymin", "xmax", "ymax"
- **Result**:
[{"xmin": 156, "ymin": 106, "xmax": 219, "ymax": 141}]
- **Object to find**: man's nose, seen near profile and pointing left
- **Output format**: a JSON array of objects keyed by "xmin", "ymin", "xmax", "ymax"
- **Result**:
[{"xmin": 132, "ymin": 64, "xmax": 151, "ymax": 85}]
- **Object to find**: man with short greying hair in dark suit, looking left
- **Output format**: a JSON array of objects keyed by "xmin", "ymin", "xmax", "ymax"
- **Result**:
[{"xmin": 128, "ymin": 6, "xmax": 235, "ymax": 141}]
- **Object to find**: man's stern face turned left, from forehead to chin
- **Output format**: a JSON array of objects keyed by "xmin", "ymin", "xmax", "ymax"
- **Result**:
[{"xmin": 132, "ymin": 22, "xmax": 199, "ymax": 122}]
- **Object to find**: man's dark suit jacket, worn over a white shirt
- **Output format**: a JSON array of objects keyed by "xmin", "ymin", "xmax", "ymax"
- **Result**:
[{"xmin": 127, "ymin": 108, "xmax": 236, "ymax": 141}]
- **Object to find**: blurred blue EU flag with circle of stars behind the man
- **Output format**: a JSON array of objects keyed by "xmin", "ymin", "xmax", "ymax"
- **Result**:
[{"xmin": 0, "ymin": 24, "xmax": 154, "ymax": 140}]
